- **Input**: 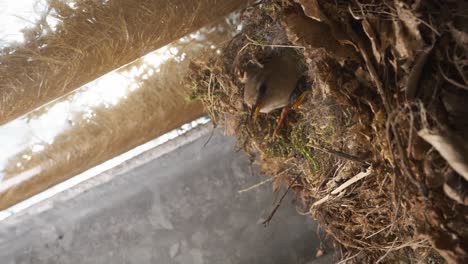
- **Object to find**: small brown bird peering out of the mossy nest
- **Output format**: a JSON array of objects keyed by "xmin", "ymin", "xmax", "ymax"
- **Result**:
[{"xmin": 243, "ymin": 49, "xmax": 307, "ymax": 135}]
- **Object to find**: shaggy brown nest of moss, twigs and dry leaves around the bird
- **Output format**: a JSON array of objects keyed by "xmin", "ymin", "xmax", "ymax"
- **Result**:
[{"xmin": 189, "ymin": 1, "xmax": 468, "ymax": 263}]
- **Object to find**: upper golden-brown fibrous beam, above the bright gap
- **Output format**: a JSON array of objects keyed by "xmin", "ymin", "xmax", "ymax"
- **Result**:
[{"xmin": 0, "ymin": 0, "xmax": 246, "ymax": 124}]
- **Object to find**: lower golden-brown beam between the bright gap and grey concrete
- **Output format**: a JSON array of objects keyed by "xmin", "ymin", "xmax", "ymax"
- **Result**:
[{"xmin": 0, "ymin": 65, "xmax": 203, "ymax": 210}]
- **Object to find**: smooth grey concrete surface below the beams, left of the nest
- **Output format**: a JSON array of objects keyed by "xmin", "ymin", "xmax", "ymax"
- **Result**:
[{"xmin": 0, "ymin": 125, "xmax": 331, "ymax": 264}]
